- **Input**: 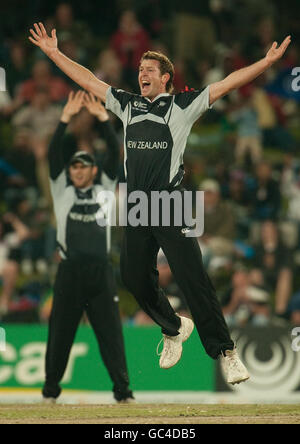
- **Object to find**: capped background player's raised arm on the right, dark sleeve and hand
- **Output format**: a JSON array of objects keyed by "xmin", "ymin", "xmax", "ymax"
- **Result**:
[{"xmin": 84, "ymin": 94, "xmax": 120, "ymax": 180}]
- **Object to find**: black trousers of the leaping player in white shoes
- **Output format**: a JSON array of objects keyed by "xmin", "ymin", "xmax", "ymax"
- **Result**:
[{"xmin": 121, "ymin": 226, "xmax": 234, "ymax": 359}]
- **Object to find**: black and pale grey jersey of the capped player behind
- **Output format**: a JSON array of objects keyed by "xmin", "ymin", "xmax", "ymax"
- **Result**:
[{"xmin": 48, "ymin": 122, "xmax": 119, "ymax": 261}]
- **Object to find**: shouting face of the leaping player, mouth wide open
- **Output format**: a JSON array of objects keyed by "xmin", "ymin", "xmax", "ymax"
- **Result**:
[{"xmin": 139, "ymin": 60, "xmax": 169, "ymax": 100}]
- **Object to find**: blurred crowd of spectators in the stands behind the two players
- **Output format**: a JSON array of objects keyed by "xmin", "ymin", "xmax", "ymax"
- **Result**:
[{"xmin": 0, "ymin": 0, "xmax": 300, "ymax": 326}]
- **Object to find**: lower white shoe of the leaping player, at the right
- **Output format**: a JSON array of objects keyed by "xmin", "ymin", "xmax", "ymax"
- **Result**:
[{"xmin": 221, "ymin": 348, "xmax": 250, "ymax": 385}]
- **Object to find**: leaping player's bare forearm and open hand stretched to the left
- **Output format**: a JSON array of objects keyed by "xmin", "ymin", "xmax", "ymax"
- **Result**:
[{"xmin": 28, "ymin": 22, "xmax": 109, "ymax": 102}]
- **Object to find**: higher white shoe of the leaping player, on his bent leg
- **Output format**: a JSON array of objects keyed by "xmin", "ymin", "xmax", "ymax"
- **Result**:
[{"xmin": 157, "ymin": 316, "xmax": 194, "ymax": 369}]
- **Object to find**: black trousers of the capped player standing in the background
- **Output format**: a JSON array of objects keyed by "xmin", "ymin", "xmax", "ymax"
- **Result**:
[{"xmin": 43, "ymin": 260, "xmax": 132, "ymax": 400}]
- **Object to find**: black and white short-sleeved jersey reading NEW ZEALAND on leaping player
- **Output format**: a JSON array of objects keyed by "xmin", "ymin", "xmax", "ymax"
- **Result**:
[{"xmin": 106, "ymin": 87, "xmax": 210, "ymax": 192}]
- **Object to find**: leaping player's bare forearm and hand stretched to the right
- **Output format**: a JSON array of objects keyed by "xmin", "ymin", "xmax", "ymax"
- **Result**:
[{"xmin": 209, "ymin": 36, "xmax": 291, "ymax": 105}]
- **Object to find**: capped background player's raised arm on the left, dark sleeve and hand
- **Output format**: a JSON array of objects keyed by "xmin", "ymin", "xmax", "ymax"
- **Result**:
[{"xmin": 48, "ymin": 91, "xmax": 85, "ymax": 180}]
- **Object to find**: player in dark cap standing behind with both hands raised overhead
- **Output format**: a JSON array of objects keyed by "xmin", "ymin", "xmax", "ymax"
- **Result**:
[{"xmin": 43, "ymin": 91, "xmax": 133, "ymax": 402}]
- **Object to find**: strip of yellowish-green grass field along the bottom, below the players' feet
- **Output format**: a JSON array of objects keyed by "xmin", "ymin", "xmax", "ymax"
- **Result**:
[{"xmin": 0, "ymin": 404, "xmax": 300, "ymax": 424}]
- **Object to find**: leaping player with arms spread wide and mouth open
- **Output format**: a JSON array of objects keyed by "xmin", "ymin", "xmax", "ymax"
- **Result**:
[{"xmin": 29, "ymin": 23, "xmax": 291, "ymax": 384}]
